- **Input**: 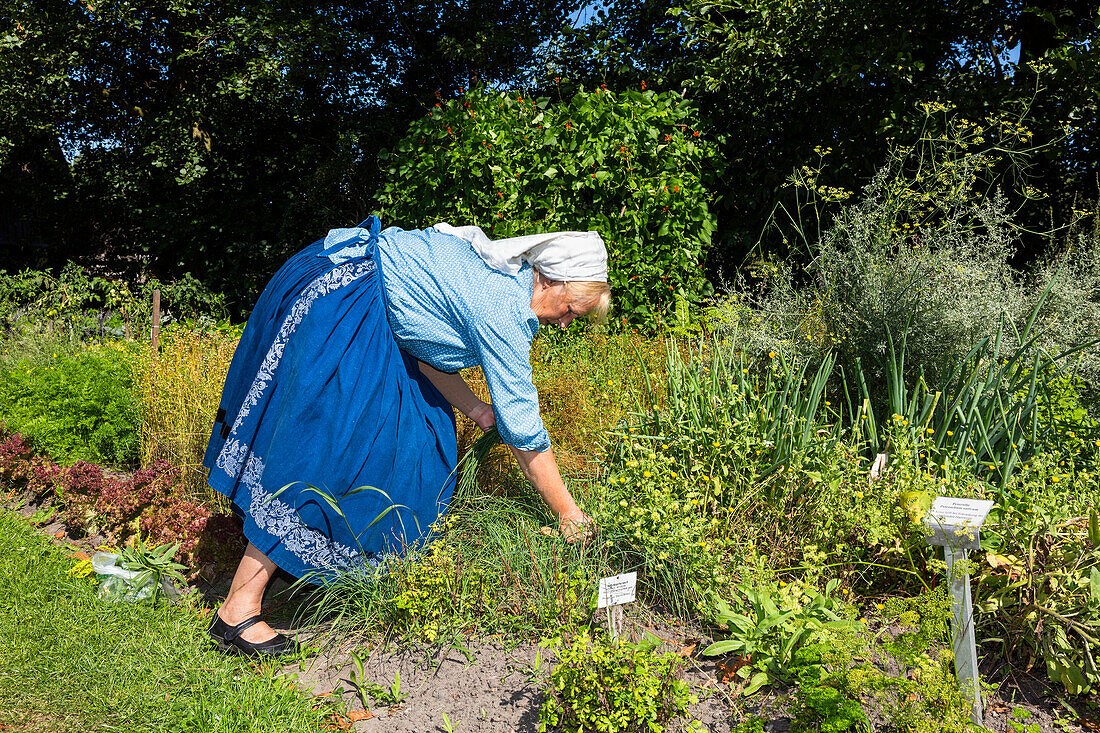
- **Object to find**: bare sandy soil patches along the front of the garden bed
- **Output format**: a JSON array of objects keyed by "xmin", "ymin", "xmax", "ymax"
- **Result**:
[{"xmin": 0, "ymin": 495, "xmax": 1100, "ymax": 733}]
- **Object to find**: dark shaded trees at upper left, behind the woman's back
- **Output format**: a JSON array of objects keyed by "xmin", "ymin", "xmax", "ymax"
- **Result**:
[{"xmin": 0, "ymin": 0, "xmax": 574, "ymax": 305}]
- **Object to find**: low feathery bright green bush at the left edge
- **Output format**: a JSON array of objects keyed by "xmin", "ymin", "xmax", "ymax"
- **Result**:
[{"xmin": 0, "ymin": 344, "xmax": 139, "ymax": 464}]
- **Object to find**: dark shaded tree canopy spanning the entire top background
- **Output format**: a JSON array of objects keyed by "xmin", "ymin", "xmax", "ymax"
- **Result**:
[{"xmin": 0, "ymin": 0, "xmax": 1100, "ymax": 305}]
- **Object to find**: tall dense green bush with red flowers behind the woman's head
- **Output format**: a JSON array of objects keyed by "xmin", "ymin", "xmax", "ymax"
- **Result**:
[{"xmin": 380, "ymin": 89, "xmax": 715, "ymax": 324}]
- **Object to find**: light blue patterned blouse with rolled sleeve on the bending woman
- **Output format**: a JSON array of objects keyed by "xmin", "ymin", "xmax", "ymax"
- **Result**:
[{"xmin": 377, "ymin": 227, "xmax": 550, "ymax": 451}]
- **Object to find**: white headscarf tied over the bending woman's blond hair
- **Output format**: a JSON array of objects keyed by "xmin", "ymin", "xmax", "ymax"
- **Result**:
[{"xmin": 433, "ymin": 221, "xmax": 607, "ymax": 283}]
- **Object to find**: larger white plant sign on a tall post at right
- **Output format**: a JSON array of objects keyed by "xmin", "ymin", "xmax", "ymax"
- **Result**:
[{"xmin": 924, "ymin": 496, "xmax": 993, "ymax": 725}]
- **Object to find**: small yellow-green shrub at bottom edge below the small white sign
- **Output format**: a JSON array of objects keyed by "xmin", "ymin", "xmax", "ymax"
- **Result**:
[{"xmin": 539, "ymin": 634, "xmax": 699, "ymax": 733}]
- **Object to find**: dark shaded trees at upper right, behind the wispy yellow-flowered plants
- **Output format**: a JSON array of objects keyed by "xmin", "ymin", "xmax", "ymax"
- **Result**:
[{"xmin": 562, "ymin": 0, "xmax": 1100, "ymax": 264}]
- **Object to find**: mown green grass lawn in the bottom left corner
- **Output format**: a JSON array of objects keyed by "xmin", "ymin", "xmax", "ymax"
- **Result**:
[{"xmin": 0, "ymin": 511, "xmax": 325, "ymax": 733}]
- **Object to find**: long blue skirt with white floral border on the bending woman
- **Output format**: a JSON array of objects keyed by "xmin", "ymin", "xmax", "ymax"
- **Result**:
[{"xmin": 204, "ymin": 236, "xmax": 458, "ymax": 582}]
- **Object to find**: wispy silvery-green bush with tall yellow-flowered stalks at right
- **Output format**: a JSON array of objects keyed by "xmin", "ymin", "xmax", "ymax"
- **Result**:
[{"xmin": 710, "ymin": 105, "xmax": 1100, "ymax": 407}]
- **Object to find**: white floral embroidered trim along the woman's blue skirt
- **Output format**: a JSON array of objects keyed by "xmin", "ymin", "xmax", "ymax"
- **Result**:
[{"xmin": 216, "ymin": 260, "xmax": 382, "ymax": 570}]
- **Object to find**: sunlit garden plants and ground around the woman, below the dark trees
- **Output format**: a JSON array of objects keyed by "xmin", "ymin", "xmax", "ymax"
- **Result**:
[{"xmin": 0, "ymin": 3, "xmax": 1100, "ymax": 733}]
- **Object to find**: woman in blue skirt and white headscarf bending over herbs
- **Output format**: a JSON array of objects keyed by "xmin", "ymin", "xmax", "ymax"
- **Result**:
[{"xmin": 204, "ymin": 217, "xmax": 608, "ymax": 656}]
